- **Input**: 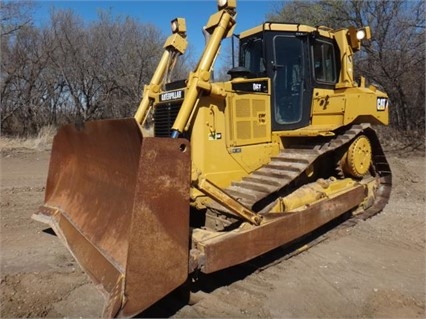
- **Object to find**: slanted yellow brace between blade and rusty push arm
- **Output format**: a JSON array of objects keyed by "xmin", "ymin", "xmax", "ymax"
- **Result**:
[{"xmin": 198, "ymin": 178, "xmax": 262, "ymax": 225}]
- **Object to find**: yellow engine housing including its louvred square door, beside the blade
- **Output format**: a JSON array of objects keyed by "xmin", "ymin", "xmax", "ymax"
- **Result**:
[{"xmin": 186, "ymin": 78, "xmax": 280, "ymax": 200}]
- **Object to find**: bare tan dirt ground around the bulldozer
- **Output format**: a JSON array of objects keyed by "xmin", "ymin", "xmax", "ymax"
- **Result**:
[{"xmin": 0, "ymin": 149, "xmax": 425, "ymax": 318}]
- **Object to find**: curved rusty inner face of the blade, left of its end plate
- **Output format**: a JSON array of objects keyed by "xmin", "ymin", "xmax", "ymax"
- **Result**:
[{"xmin": 45, "ymin": 119, "xmax": 142, "ymax": 271}]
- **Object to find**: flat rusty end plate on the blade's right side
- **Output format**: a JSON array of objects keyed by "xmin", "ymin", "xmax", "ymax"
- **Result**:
[{"xmin": 121, "ymin": 138, "xmax": 190, "ymax": 317}]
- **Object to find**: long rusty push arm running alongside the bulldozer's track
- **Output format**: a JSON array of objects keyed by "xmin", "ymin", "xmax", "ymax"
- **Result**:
[{"xmin": 197, "ymin": 186, "xmax": 365, "ymax": 273}]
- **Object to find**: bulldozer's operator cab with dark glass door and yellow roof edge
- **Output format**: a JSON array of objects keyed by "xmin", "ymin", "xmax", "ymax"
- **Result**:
[{"xmin": 239, "ymin": 23, "xmax": 340, "ymax": 131}]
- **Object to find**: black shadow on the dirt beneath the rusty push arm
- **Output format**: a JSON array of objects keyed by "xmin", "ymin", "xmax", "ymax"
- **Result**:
[{"xmin": 135, "ymin": 212, "xmax": 352, "ymax": 318}]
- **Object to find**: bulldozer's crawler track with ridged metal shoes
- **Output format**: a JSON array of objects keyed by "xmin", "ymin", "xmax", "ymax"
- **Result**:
[{"xmin": 209, "ymin": 124, "xmax": 392, "ymax": 219}]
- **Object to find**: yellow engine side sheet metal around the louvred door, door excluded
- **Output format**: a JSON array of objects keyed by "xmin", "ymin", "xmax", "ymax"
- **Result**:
[{"xmin": 190, "ymin": 92, "xmax": 280, "ymax": 207}]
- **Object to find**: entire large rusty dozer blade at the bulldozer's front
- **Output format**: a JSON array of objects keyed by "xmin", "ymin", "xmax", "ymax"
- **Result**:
[{"xmin": 33, "ymin": 119, "xmax": 190, "ymax": 317}]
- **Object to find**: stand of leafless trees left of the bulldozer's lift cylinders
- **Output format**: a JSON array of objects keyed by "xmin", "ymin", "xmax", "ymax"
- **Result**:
[{"xmin": 0, "ymin": 2, "xmax": 192, "ymax": 135}]
